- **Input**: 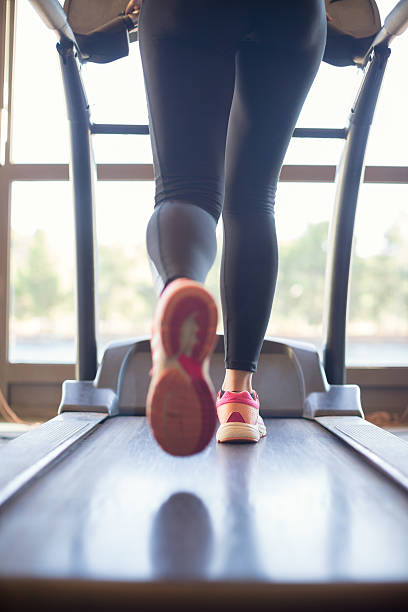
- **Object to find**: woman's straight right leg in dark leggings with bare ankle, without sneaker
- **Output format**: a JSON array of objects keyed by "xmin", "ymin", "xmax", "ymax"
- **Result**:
[{"xmin": 221, "ymin": 0, "xmax": 326, "ymax": 391}]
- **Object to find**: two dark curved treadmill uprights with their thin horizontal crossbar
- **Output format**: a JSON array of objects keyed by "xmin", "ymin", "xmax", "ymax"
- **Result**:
[{"xmin": 57, "ymin": 25, "xmax": 390, "ymax": 384}]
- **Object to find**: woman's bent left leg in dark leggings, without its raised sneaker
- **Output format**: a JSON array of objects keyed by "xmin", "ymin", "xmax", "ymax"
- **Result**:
[{"xmin": 140, "ymin": 0, "xmax": 247, "ymax": 289}]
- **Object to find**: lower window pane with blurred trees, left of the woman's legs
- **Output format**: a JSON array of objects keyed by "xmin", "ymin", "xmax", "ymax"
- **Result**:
[{"xmin": 9, "ymin": 182, "xmax": 156, "ymax": 363}]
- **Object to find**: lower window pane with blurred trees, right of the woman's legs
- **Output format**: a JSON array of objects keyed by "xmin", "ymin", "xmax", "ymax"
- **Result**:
[{"xmin": 249, "ymin": 183, "xmax": 408, "ymax": 366}]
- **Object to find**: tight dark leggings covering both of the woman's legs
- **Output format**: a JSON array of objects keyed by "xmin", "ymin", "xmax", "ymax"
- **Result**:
[{"xmin": 140, "ymin": 0, "xmax": 326, "ymax": 372}]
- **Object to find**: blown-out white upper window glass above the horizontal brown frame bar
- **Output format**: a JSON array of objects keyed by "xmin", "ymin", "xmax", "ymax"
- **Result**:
[{"xmin": 12, "ymin": 0, "xmax": 408, "ymax": 165}]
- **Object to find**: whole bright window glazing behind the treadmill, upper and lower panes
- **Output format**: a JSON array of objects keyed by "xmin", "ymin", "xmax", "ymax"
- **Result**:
[{"xmin": 0, "ymin": 0, "xmax": 408, "ymax": 416}]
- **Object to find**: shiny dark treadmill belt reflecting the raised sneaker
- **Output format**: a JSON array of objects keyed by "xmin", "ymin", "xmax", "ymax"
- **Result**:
[{"xmin": 0, "ymin": 417, "xmax": 408, "ymax": 583}]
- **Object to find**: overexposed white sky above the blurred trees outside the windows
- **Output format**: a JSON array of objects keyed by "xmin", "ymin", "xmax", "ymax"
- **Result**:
[{"xmin": 8, "ymin": 0, "xmax": 408, "ymax": 256}]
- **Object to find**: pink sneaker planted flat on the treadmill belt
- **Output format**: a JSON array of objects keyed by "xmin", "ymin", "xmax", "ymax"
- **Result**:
[{"xmin": 216, "ymin": 391, "xmax": 266, "ymax": 442}]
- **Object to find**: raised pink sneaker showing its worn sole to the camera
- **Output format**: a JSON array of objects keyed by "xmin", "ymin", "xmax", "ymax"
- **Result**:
[{"xmin": 146, "ymin": 278, "xmax": 217, "ymax": 455}]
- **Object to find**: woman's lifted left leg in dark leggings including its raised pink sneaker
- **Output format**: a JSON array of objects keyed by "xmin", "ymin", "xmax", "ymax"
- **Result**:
[{"xmin": 140, "ymin": 0, "xmax": 252, "ymax": 455}]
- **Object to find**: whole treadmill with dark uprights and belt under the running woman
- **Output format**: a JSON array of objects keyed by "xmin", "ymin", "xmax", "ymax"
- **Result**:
[{"xmin": 0, "ymin": 0, "xmax": 408, "ymax": 612}]
